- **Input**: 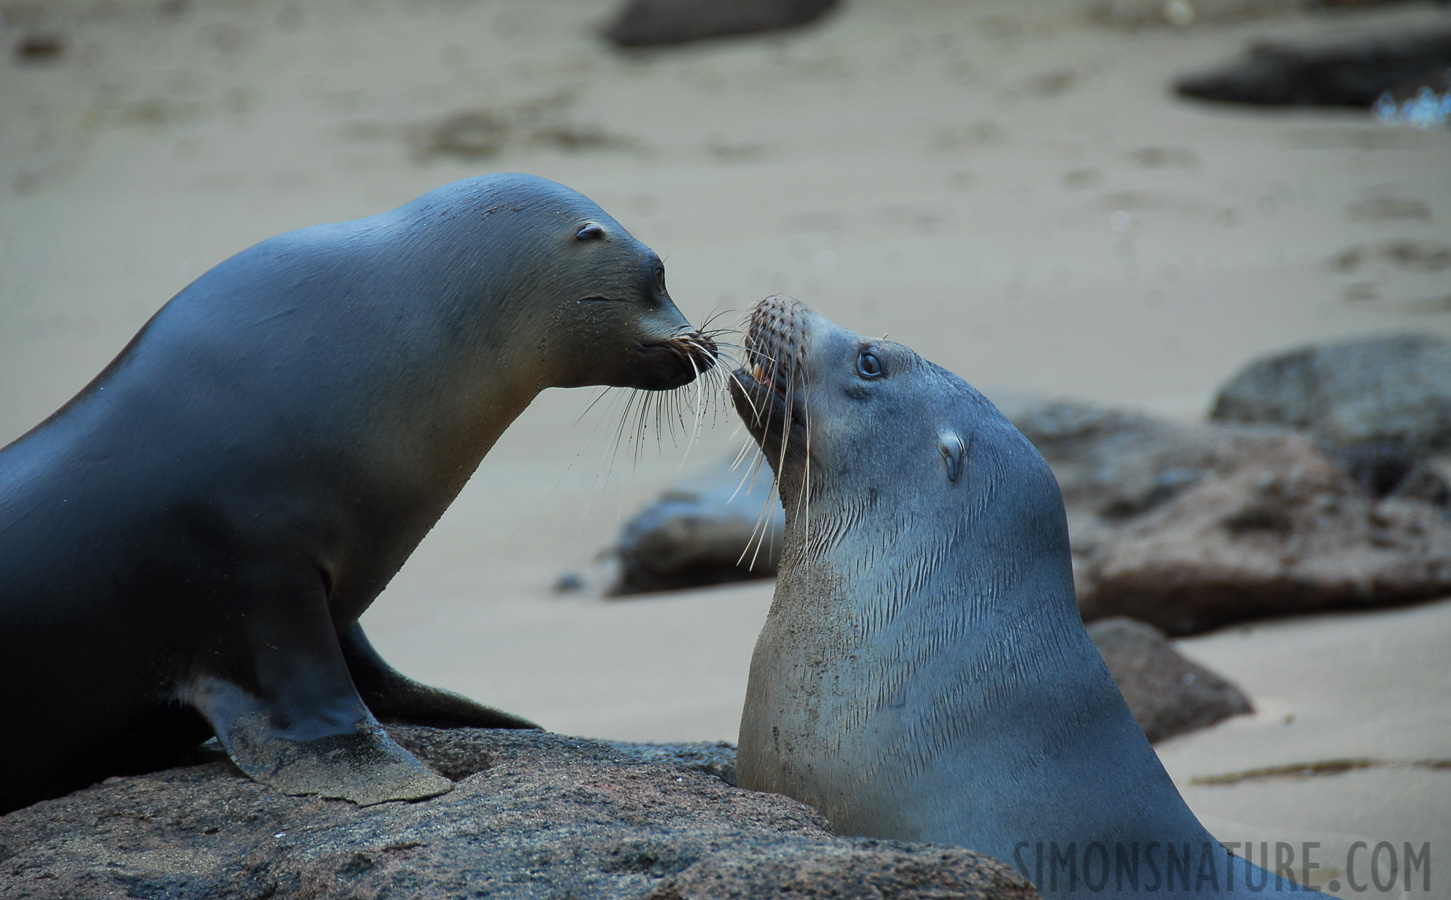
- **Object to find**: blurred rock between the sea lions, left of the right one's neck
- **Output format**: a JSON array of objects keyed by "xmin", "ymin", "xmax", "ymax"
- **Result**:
[{"xmin": 609, "ymin": 462, "xmax": 785, "ymax": 595}]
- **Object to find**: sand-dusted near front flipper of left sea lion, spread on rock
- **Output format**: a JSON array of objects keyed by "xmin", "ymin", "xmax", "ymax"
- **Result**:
[{"xmin": 184, "ymin": 598, "xmax": 453, "ymax": 806}]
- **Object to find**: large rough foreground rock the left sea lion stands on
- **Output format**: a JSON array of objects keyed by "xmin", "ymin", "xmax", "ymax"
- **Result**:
[{"xmin": 0, "ymin": 727, "xmax": 1037, "ymax": 900}]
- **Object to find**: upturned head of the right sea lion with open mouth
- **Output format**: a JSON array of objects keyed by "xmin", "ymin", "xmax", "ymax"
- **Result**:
[{"xmin": 731, "ymin": 295, "xmax": 1064, "ymax": 541}]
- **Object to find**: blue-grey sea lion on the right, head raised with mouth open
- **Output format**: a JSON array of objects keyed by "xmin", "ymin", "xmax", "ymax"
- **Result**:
[{"xmin": 731, "ymin": 296, "xmax": 1329, "ymax": 896}]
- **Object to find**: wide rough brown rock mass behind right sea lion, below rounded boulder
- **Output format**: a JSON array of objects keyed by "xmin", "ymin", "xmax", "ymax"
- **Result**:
[{"xmin": 994, "ymin": 395, "xmax": 1451, "ymax": 634}]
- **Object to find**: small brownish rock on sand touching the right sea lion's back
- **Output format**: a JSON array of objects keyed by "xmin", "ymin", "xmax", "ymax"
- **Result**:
[{"xmin": 1088, "ymin": 617, "xmax": 1254, "ymax": 742}]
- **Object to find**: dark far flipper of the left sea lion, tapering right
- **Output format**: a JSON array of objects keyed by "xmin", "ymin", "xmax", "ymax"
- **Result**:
[{"xmin": 338, "ymin": 623, "xmax": 540, "ymax": 729}]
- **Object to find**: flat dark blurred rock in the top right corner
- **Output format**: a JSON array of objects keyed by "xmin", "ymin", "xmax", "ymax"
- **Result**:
[{"xmin": 1174, "ymin": 29, "xmax": 1451, "ymax": 107}]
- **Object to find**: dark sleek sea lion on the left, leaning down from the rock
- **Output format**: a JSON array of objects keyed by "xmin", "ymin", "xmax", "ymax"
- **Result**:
[{"xmin": 0, "ymin": 174, "xmax": 715, "ymax": 811}]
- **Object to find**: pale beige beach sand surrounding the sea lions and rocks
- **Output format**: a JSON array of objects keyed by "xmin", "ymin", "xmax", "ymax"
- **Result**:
[{"xmin": 0, "ymin": 0, "xmax": 1451, "ymax": 896}]
